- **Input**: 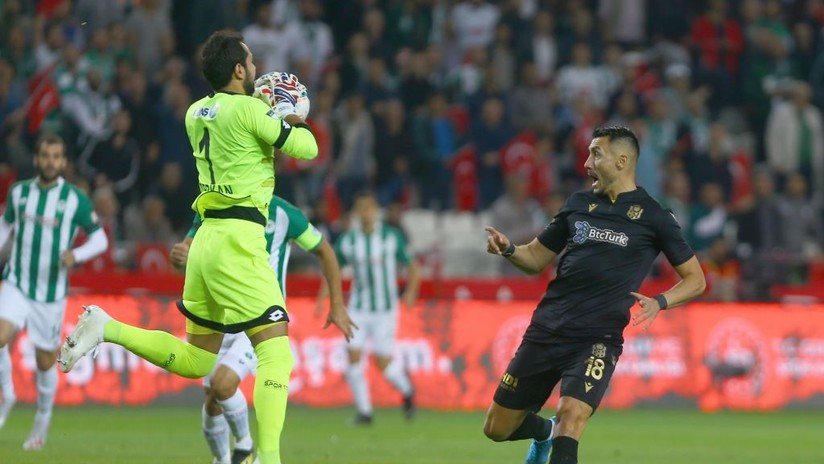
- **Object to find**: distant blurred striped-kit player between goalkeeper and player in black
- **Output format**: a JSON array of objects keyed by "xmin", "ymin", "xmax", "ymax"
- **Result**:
[{"xmin": 335, "ymin": 192, "xmax": 420, "ymax": 425}]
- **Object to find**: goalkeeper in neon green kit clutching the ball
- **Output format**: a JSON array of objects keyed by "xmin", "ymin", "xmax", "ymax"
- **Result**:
[{"xmin": 60, "ymin": 31, "xmax": 318, "ymax": 464}]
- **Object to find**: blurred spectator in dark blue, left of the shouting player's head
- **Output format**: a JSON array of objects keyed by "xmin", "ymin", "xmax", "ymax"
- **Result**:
[{"xmin": 471, "ymin": 98, "xmax": 515, "ymax": 209}]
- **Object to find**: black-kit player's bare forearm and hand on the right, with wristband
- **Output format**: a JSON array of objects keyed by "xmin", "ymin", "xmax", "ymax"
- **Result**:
[{"xmin": 631, "ymin": 256, "xmax": 707, "ymax": 329}]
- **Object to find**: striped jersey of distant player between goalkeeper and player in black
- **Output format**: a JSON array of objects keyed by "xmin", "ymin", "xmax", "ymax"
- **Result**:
[{"xmin": 335, "ymin": 223, "xmax": 411, "ymax": 312}]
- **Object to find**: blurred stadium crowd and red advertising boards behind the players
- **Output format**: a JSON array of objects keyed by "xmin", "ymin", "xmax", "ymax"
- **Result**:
[{"xmin": 0, "ymin": 0, "xmax": 824, "ymax": 462}]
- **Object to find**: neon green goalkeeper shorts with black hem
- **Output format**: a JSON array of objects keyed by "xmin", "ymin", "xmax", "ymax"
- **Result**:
[{"xmin": 177, "ymin": 218, "xmax": 289, "ymax": 333}]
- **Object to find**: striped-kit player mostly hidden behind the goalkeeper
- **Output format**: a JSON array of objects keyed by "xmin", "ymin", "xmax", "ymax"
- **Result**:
[{"xmin": 170, "ymin": 196, "xmax": 352, "ymax": 464}]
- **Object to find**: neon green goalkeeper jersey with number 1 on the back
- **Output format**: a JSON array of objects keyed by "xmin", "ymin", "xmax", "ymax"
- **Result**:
[{"xmin": 186, "ymin": 92, "xmax": 318, "ymax": 217}]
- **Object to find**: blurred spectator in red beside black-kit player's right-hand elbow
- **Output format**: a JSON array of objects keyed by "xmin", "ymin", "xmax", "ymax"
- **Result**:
[{"xmin": 701, "ymin": 237, "xmax": 740, "ymax": 303}]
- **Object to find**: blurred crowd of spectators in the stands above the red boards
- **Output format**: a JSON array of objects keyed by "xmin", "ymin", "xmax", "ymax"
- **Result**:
[{"xmin": 0, "ymin": 0, "xmax": 824, "ymax": 300}]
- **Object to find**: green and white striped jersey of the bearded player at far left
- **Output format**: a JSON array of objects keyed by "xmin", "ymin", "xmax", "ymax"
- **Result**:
[{"xmin": 3, "ymin": 177, "xmax": 100, "ymax": 303}]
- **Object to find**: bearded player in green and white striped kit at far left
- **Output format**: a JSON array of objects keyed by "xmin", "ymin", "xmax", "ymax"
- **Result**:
[{"xmin": 0, "ymin": 135, "xmax": 108, "ymax": 450}]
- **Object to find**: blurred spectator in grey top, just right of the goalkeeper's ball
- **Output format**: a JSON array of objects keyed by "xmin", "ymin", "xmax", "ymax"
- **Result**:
[{"xmin": 335, "ymin": 93, "xmax": 375, "ymax": 209}]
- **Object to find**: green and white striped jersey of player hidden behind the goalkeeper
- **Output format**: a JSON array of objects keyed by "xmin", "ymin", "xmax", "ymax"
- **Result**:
[{"xmin": 187, "ymin": 195, "xmax": 323, "ymax": 298}]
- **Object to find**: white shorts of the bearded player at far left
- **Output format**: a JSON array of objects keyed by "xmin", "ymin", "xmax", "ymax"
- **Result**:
[{"xmin": 0, "ymin": 282, "xmax": 66, "ymax": 351}]
